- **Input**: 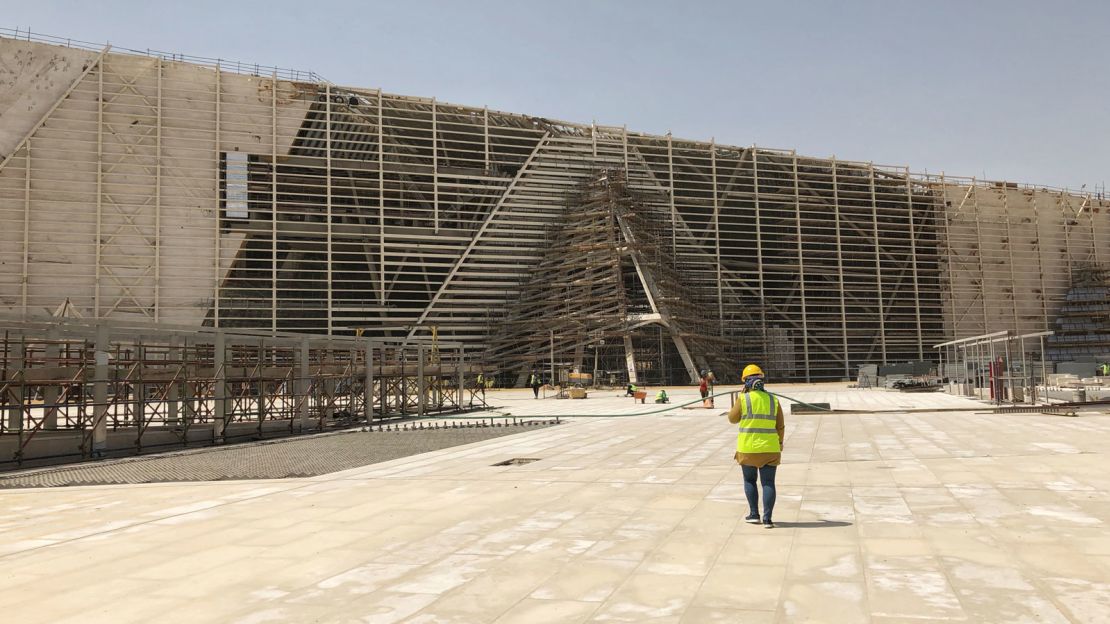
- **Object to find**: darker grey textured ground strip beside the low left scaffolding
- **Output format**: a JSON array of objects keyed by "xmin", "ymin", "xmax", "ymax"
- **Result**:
[{"xmin": 0, "ymin": 419, "xmax": 555, "ymax": 489}]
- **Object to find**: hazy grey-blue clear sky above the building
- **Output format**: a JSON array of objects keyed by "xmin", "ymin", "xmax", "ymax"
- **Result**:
[{"xmin": 8, "ymin": 0, "xmax": 1110, "ymax": 190}]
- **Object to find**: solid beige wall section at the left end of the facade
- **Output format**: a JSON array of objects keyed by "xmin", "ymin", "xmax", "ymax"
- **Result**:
[{"xmin": 0, "ymin": 40, "xmax": 311, "ymax": 324}]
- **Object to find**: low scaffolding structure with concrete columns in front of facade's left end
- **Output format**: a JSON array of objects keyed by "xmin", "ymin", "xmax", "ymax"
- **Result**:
[{"xmin": 0, "ymin": 319, "xmax": 472, "ymax": 463}]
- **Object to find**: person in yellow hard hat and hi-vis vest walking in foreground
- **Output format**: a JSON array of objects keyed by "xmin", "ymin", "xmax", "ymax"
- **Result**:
[{"xmin": 728, "ymin": 364, "xmax": 786, "ymax": 529}]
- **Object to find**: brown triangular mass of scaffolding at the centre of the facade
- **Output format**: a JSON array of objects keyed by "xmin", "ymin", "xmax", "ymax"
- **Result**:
[{"xmin": 485, "ymin": 169, "xmax": 729, "ymax": 384}]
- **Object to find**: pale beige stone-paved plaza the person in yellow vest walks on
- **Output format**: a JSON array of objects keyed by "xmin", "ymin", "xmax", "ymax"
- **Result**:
[{"xmin": 0, "ymin": 386, "xmax": 1110, "ymax": 624}]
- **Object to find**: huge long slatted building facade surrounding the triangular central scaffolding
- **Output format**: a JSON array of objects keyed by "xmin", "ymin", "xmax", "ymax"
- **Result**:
[{"xmin": 0, "ymin": 33, "xmax": 1110, "ymax": 381}]
